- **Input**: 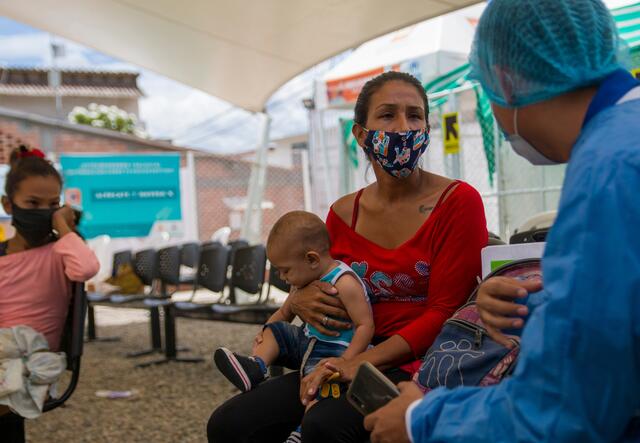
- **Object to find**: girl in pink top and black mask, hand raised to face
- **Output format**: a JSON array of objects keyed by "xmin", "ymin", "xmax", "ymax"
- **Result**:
[{"xmin": 0, "ymin": 146, "xmax": 100, "ymax": 351}]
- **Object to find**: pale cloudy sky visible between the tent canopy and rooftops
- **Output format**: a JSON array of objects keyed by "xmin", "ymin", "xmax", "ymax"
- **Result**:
[{"xmin": 0, "ymin": 0, "xmax": 637, "ymax": 153}]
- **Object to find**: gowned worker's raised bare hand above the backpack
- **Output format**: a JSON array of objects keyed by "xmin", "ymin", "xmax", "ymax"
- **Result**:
[{"xmin": 476, "ymin": 277, "xmax": 542, "ymax": 349}]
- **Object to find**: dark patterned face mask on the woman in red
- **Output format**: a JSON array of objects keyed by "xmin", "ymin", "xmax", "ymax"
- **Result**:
[{"xmin": 364, "ymin": 128, "xmax": 430, "ymax": 178}]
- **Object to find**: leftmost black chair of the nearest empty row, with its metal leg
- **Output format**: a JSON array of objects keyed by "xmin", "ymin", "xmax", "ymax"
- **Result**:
[{"xmin": 138, "ymin": 244, "xmax": 230, "ymax": 367}]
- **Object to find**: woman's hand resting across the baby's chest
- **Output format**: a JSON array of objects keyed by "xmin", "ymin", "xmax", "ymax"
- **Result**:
[{"xmin": 289, "ymin": 281, "xmax": 352, "ymax": 337}]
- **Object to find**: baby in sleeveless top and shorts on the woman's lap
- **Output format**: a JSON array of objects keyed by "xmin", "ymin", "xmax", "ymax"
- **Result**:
[{"xmin": 214, "ymin": 211, "xmax": 374, "ymax": 442}]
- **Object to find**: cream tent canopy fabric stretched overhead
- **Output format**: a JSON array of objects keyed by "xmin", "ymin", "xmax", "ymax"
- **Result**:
[{"xmin": 0, "ymin": 0, "xmax": 479, "ymax": 111}]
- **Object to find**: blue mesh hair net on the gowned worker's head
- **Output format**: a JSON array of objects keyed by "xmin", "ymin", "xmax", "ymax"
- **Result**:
[{"xmin": 470, "ymin": 0, "xmax": 628, "ymax": 108}]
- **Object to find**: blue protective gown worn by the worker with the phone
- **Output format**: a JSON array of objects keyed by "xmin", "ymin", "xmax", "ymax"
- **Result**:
[{"xmin": 407, "ymin": 74, "xmax": 640, "ymax": 443}]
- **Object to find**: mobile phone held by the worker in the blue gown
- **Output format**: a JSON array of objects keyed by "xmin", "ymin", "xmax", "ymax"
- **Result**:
[{"xmin": 347, "ymin": 362, "xmax": 400, "ymax": 415}]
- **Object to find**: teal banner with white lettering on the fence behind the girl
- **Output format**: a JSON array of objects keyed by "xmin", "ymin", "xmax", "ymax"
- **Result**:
[{"xmin": 60, "ymin": 154, "xmax": 182, "ymax": 238}]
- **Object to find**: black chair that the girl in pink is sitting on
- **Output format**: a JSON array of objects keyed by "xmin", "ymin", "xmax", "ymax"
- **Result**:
[{"xmin": 0, "ymin": 283, "xmax": 88, "ymax": 443}]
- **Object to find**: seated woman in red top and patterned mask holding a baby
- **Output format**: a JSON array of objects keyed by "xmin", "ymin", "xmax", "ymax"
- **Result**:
[{"xmin": 208, "ymin": 72, "xmax": 487, "ymax": 443}]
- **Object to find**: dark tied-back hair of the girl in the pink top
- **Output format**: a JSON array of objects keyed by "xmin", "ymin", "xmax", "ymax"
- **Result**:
[{"xmin": 4, "ymin": 145, "xmax": 62, "ymax": 200}]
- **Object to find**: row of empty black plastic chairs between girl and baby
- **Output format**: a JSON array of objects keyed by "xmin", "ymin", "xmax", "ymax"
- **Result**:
[{"xmin": 87, "ymin": 240, "xmax": 289, "ymax": 366}]
